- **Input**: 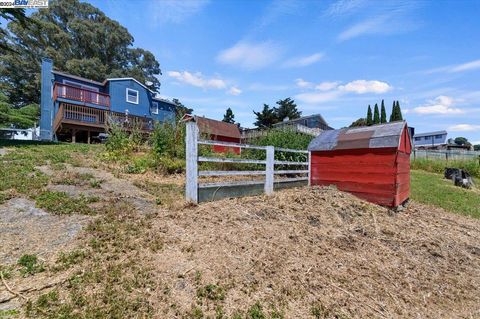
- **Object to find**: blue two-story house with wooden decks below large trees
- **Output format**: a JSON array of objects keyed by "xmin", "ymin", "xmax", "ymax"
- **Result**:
[{"xmin": 40, "ymin": 59, "xmax": 176, "ymax": 143}]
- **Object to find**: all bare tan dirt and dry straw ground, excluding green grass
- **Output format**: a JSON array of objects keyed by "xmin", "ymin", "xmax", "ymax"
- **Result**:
[{"xmin": 0, "ymin": 151, "xmax": 480, "ymax": 318}]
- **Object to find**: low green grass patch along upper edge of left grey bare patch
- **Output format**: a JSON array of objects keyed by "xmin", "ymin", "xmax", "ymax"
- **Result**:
[{"xmin": 35, "ymin": 191, "xmax": 98, "ymax": 215}]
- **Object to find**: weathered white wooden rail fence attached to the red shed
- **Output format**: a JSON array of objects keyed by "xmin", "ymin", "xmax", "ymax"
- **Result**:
[{"xmin": 185, "ymin": 122, "xmax": 310, "ymax": 203}]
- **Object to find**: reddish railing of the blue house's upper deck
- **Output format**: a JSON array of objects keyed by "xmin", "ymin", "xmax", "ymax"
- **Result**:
[{"xmin": 53, "ymin": 82, "xmax": 110, "ymax": 108}]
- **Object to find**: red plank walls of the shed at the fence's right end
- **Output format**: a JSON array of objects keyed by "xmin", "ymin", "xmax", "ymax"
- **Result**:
[{"xmin": 310, "ymin": 126, "xmax": 411, "ymax": 207}]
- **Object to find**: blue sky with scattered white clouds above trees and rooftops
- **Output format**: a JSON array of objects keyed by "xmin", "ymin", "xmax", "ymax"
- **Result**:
[{"xmin": 89, "ymin": 0, "xmax": 480, "ymax": 144}]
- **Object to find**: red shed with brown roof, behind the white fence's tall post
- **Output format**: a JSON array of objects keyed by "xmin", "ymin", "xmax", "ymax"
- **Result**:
[{"xmin": 182, "ymin": 114, "xmax": 241, "ymax": 154}]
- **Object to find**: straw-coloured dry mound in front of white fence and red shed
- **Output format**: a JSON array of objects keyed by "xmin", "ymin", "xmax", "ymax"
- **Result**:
[{"xmin": 146, "ymin": 188, "xmax": 480, "ymax": 318}]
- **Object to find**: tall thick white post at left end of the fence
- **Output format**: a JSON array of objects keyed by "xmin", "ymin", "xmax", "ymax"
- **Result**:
[{"xmin": 185, "ymin": 121, "xmax": 198, "ymax": 204}]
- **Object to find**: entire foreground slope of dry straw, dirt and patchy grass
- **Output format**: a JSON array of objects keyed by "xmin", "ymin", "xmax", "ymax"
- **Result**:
[{"xmin": 0, "ymin": 145, "xmax": 480, "ymax": 318}]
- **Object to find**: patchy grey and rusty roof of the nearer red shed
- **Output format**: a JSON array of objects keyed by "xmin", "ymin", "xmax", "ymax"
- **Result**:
[{"xmin": 308, "ymin": 121, "xmax": 406, "ymax": 151}]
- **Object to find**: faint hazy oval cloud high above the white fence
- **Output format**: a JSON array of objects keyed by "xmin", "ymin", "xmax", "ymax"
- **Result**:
[{"xmin": 217, "ymin": 41, "xmax": 281, "ymax": 70}]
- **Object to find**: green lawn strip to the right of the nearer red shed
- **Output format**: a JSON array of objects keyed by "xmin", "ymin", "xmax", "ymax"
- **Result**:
[{"xmin": 411, "ymin": 170, "xmax": 480, "ymax": 218}]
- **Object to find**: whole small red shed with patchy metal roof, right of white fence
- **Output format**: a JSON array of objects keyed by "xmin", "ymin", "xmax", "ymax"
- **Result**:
[{"xmin": 308, "ymin": 121, "xmax": 412, "ymax": 207}]
